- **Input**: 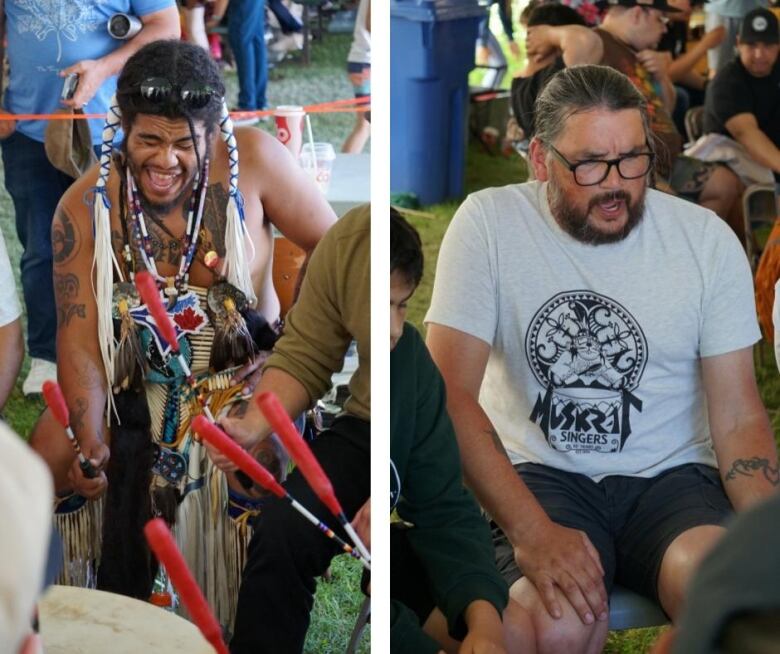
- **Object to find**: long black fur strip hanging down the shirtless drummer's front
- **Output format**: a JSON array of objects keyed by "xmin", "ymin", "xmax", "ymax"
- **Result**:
[{"xmin": 97, "ymin": 390, "xmax": 157, "ymax": 601}]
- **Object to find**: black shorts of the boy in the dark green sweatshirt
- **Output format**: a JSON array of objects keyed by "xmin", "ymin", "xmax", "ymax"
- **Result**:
[{"xmin": 390, "ymin": 522, "xmax": 436, "ymax": 626}]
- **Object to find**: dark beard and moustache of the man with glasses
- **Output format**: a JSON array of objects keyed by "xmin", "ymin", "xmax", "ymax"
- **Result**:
[{"xmin": 547, "ymin": 178, "xmax": 645, "ymax": 245}]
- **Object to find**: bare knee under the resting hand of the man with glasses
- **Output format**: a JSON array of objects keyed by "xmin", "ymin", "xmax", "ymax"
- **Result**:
[{"xmin": 509, "ymin": 578, "xmax": 607, "ymax": 654}]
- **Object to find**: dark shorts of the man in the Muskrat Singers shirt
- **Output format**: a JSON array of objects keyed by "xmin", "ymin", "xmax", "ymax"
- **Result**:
[{"xmin": 492, "ymin": 463, "xmax": 733, "ymax": 601}]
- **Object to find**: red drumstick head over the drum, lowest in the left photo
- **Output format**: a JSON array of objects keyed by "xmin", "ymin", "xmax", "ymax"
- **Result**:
[{"xmin": 144, "ymin": 518, "xmax": 228, "ymax": 654}]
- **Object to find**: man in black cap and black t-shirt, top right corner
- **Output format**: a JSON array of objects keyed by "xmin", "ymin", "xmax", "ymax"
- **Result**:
[{"xmin": 704, "ymin": 9, "xmax": 780, "ymax": 183}]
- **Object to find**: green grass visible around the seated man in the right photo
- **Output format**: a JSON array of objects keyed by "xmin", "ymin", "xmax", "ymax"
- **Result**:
[{"xmin": 408, "ymin": 143, "xmax": 780, "ymax": 654}]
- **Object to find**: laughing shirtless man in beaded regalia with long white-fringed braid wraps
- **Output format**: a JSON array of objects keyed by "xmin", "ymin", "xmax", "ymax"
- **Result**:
[{"xmin": 31, "ymin": 41, "xmax": 335, "ymax": 624}]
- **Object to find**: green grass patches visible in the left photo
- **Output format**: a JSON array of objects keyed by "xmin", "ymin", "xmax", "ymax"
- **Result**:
[{"xmin": 0, "ymin": 28, "xmax": 370, "ymax": 654}]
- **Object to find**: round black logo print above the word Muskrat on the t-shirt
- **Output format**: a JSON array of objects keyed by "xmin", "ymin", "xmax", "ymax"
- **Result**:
[{"xmin": 526, "ymin": 291, "xmax": 647, "ymax": 390}]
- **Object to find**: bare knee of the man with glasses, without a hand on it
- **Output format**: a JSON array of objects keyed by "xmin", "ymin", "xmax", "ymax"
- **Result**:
[{"xmin": 658, "ymin": 525, "xmax": 725, "ymax": 620}]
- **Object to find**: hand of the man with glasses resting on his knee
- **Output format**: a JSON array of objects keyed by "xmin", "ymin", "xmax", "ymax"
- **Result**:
[{"xmin": 514, "ymin": 522, "xmax": 609, "ymax": 624}]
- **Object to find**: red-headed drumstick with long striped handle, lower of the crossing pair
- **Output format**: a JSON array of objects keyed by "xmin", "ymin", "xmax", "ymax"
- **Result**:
[{"xmin": 192, "ymin": 416, "xmax": 371, "ymax": 570}]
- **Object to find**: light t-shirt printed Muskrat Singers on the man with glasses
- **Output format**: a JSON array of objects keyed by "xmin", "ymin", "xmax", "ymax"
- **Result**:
[{"xmin": 426, "ymin": 182, "xmax": 760, "ymax": 481}]
